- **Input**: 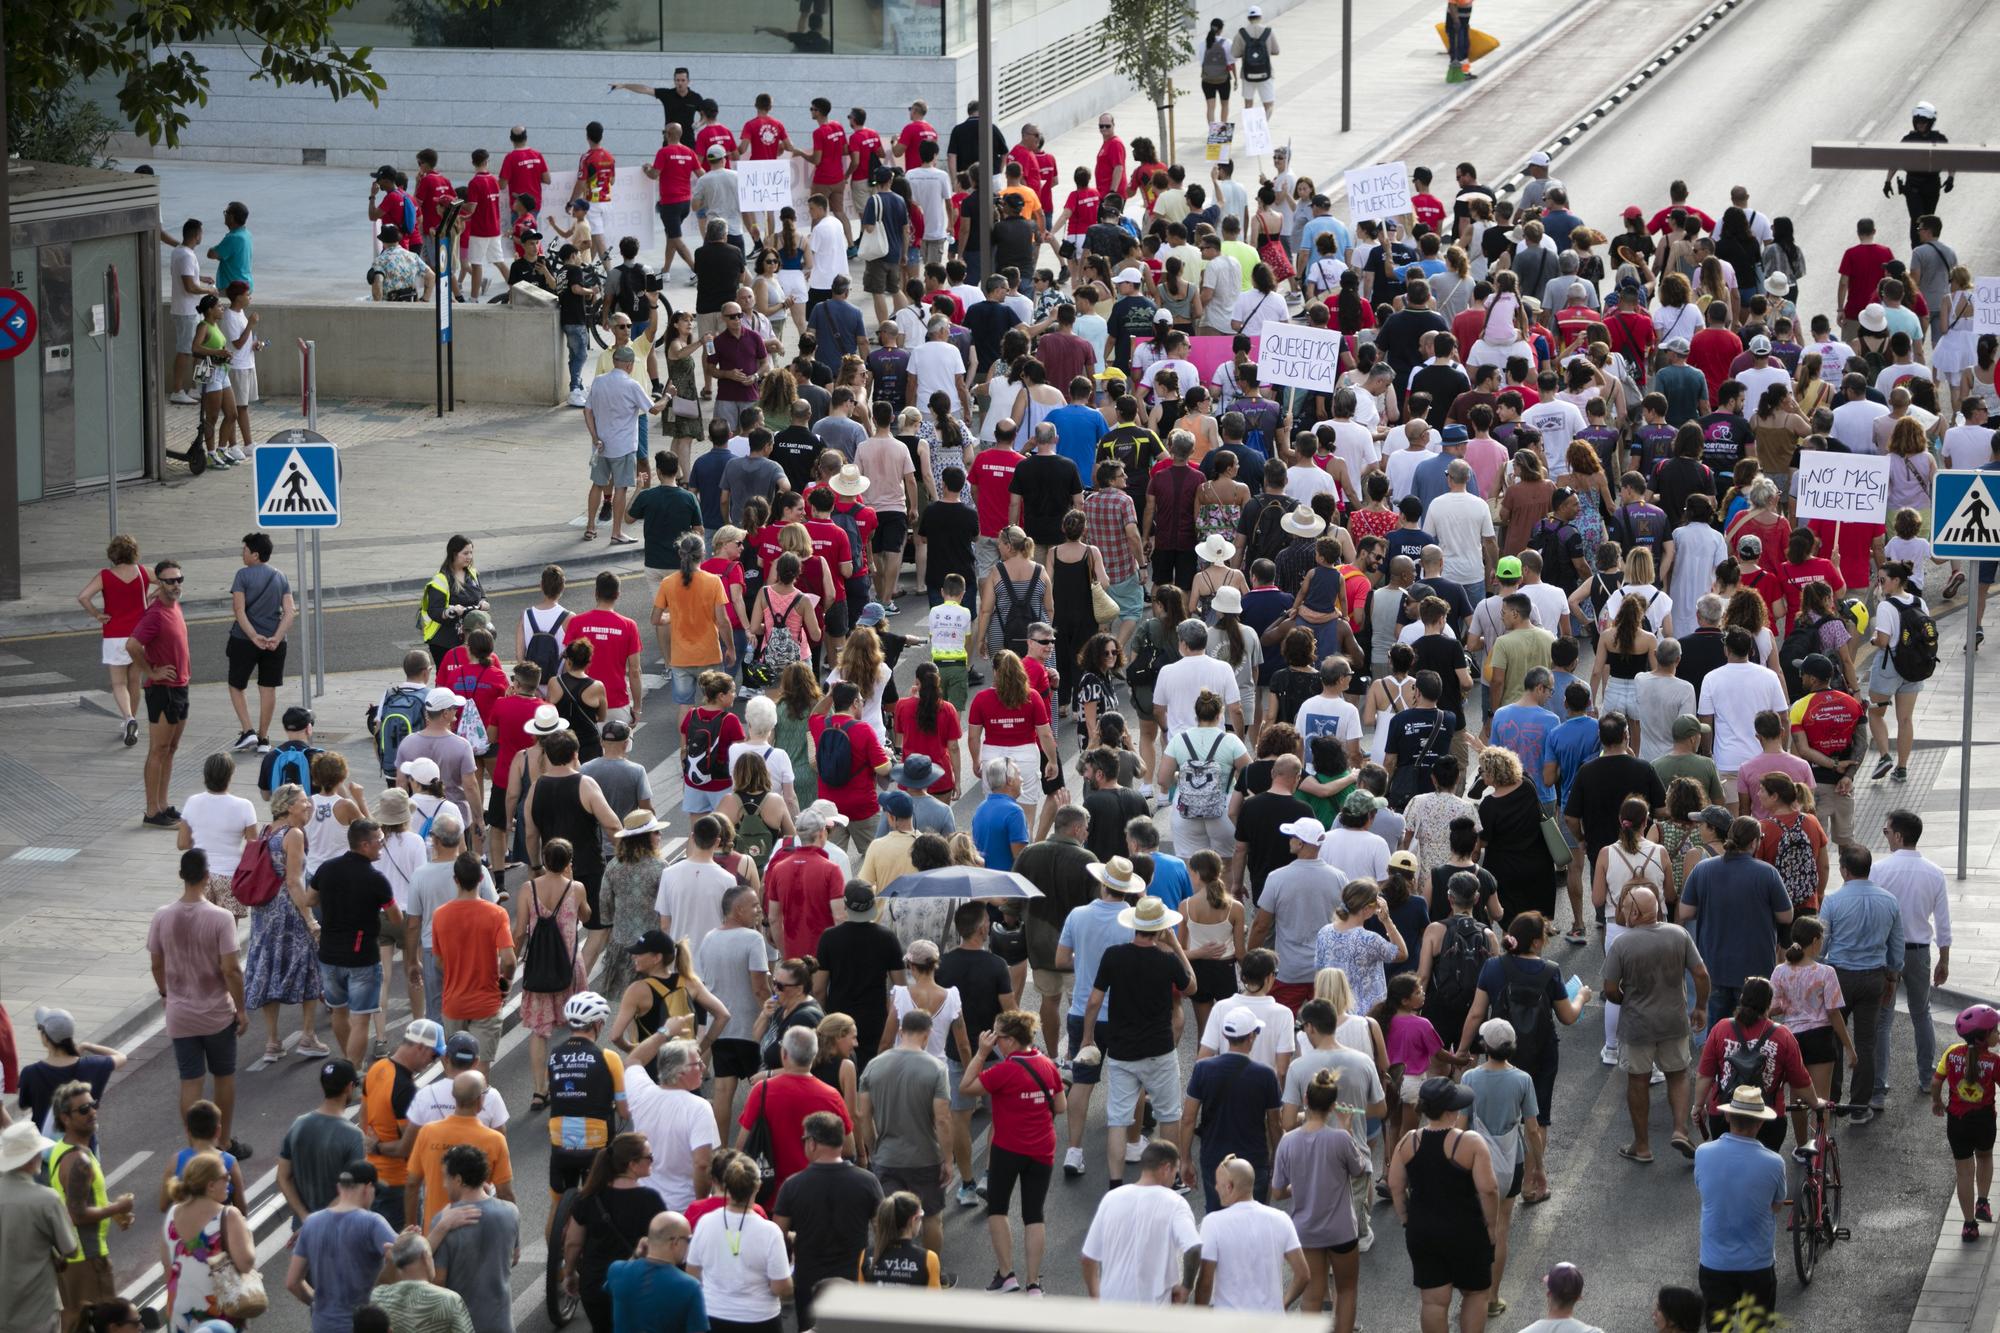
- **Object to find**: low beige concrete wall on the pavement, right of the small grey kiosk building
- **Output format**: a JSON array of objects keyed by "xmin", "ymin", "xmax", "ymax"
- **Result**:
[{"xmin": 162, "ymin": 300, "xmax": 570, "ymax": 406}]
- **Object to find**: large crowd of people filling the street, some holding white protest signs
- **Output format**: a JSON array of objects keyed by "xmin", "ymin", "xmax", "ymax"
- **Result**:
[{"xmin": 15, "ymin": 59, "xmax": 2000, "ymax": 1333}]
